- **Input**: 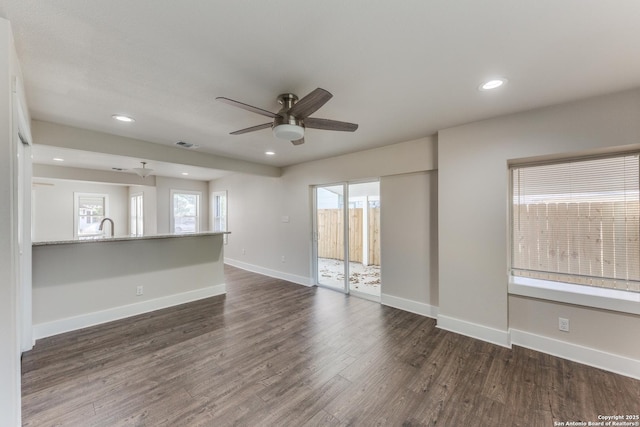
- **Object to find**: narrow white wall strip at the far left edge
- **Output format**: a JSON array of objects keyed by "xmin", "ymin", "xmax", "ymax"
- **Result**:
[{"xmin": 0, "ymin": 18, "xmax": 26, "ymax": 426}]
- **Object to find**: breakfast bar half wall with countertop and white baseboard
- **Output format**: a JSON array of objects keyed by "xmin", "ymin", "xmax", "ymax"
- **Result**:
[{"xmin": 33, "ymin": 232, "xmax": 228, "ymax": 339}]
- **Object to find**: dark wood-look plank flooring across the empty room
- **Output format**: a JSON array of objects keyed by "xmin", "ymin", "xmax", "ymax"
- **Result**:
[{"xmin": 22, "ymin": 267, "xmax": 640, "ymax": 427}]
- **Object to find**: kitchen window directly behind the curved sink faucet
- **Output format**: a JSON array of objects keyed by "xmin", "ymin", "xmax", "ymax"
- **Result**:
[{"xmin": 73, "ymin": 193, "xmax": 111, "ymax": 240}]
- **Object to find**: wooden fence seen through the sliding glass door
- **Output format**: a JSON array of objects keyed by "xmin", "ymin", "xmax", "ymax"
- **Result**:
[{"xmin": 318, "ymin": 208, "xmax": 380, "ymax": 265}]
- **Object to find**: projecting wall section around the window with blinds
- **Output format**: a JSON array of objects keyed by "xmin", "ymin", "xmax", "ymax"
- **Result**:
[{"xmin": 438, "ymin": 90, "xmax": 640, "ymax": 361}]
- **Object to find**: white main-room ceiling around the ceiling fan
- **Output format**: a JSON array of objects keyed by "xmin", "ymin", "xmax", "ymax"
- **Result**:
[{"xmin": 0, "ymin": 0, "xmax": 640, "ymax": 176}]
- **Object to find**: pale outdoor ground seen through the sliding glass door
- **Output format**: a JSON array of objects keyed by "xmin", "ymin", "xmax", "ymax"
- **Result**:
[{"xmin": 318, "ymin": 258, "xmax": 380, "ymax": 296}]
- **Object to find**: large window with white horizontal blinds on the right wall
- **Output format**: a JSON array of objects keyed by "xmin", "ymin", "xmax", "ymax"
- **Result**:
[{"xmin": 510, "ymin": 153, "xmax": 640, "ymax": 292}]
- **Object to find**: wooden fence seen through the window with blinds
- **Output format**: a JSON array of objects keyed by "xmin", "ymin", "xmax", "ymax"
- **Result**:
[{"xmin": 512, "ymin": 201, "xmax": 640, "ymax": 291}]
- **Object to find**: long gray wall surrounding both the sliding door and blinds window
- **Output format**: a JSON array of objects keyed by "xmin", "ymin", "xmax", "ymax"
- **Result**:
[{"xmin": 210, "ymin": 90, "xmax": 640, "ymax": 377}]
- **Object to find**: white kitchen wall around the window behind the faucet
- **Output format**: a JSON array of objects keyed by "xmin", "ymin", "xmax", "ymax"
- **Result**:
[{"xmin": 32, "ymin": 178, "xmax": 129, "ymax": 242}]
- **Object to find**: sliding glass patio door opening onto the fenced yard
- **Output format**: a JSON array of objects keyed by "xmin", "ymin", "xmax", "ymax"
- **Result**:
[{"xmin": 314, "ymin": 181, "xmax": 382, "ymax": 301}]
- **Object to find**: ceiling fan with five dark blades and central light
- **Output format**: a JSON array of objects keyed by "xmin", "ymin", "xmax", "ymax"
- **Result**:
[{"xmin": 216, "ymin": 88, "xmax": 358, "ymax": 145}]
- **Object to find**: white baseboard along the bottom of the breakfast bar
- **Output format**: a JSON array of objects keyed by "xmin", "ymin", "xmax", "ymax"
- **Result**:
[{"xmin": 33, "ymin": 283, "xmax": 227, "ymax": 342}]
